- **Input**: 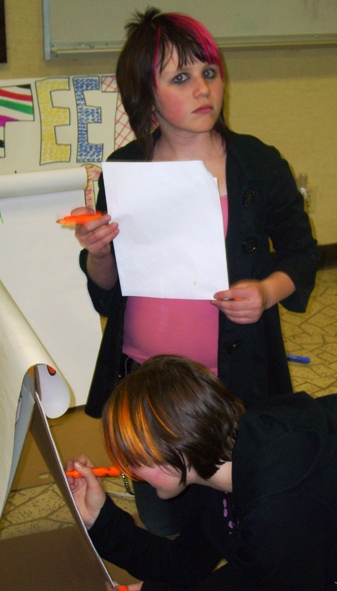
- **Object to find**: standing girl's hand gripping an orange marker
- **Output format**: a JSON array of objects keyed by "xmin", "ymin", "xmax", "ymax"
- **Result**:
[{"xmin": 71, "ymin": 207, "xmax": 119, "ymax": 259}]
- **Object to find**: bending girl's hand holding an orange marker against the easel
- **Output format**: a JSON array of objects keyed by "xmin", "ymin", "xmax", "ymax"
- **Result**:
[{"xmin": 66, "ymin": 456, "xmax": 106, "ymax": 529}]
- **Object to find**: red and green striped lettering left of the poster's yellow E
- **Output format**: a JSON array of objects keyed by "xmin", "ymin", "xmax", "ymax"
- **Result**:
[{"xmin": 0, "ymin": 84, "xmax": 34, "ymax": 158}]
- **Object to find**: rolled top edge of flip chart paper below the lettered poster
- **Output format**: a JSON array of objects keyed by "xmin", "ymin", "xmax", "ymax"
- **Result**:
[{"xmin": 0, "ymin": 166, "xmax": 87, "ymax": 198}]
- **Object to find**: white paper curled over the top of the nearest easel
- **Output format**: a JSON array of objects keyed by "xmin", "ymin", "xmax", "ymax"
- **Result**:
[{"xmin": 0, "ymin": 281, "xmax": 70, "ymax": 517}]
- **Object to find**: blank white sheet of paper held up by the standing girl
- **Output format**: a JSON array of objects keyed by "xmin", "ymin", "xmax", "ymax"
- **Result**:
[{"xmin": 102, "ymin": 161, "xmax": 228, "ymax": 300}]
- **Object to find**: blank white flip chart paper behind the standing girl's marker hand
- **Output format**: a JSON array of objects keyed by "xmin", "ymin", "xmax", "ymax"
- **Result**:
[{"xmin": 0, "ymin": 169, "xmax": 102, "ymax": 406}]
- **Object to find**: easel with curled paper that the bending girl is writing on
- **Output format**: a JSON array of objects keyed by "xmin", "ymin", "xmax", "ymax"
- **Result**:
[{"xmin": 0, "ymin": 282, "xmax": 112, "ymax": 591}]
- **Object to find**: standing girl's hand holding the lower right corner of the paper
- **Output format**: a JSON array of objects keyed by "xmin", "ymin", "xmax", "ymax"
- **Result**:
[{"xmin": 211, "ymin": 281, "xmax": 267, "ymax": 324}]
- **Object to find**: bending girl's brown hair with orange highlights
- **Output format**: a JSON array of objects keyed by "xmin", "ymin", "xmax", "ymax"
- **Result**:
[{"xmin": 103, "ymin": 355, "xmax": 244, "ymax": 483}]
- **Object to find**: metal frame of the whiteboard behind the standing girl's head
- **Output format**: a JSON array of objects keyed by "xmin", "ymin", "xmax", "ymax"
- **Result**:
[{"xmin": 43, "ymin": 0, "xmax": 337, "ymax": 60}]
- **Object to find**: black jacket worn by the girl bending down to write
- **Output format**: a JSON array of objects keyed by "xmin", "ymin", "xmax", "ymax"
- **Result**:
[{"xmin": 89, "ymin": 392, "xmax": 337, "ymax": 591}]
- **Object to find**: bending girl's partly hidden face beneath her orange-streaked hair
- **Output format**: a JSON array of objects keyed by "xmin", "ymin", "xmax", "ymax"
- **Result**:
[{"xmin": 132, "ymin": 466, "xmax": 187, "ymax": 499}]
